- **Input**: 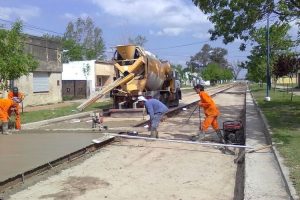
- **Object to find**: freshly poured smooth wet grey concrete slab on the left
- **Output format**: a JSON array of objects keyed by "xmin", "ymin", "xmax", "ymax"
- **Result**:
[{"xmin": 0, "ymin": 131, "xmax": 101, "ymax": 182}]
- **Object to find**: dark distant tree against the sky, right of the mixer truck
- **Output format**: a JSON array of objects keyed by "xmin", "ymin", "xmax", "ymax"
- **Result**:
[{"xmin": 186, "ymin": 44, "xmax": 228, "ymax": 72}]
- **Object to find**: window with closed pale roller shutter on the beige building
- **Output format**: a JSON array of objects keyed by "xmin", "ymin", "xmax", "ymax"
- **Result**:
[{"xmin": 33, "ymin": 72, "xmax": 49, "ymax": 93}]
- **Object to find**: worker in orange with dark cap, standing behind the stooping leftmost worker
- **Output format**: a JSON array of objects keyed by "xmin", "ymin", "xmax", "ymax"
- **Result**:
[{"xmin": 8, "ymin": 87, "xmax": 24, "ymax": 130}]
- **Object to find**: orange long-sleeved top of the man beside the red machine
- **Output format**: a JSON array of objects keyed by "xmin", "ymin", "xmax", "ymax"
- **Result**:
[{"xmin": 199, "ymin": 91, "xmax": 220, "ymax": 116}]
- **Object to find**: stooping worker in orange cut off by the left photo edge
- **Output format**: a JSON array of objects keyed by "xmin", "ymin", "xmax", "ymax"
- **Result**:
[{"xmin": 0, "ymin": 99, "xmax": 17, "ymax": 134}]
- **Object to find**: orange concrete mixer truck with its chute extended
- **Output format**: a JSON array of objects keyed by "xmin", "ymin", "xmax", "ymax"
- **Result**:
[{"xmin": 78, "ymin": 45, "xmax": 181, "ymax": 110}]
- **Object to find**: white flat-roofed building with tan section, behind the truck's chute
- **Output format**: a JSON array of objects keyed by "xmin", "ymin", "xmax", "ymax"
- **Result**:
[{"xmin": 62, "ymin": 60, "xmax": 114, "ymax": 100}]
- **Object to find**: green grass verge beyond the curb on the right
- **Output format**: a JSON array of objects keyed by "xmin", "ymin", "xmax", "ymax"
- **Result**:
[{"xmin": 251, "ymin": 85, "xmax": 300, "ymax": 194}]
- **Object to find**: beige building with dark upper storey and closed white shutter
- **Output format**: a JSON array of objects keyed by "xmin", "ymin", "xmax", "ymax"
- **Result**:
[{"xmin": 13, "ymin": 36, "xmax": 62, "ymax": 107}]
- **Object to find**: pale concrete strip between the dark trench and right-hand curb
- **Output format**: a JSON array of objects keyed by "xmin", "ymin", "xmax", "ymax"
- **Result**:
[{"xmin": 244, "ymin": 92, "xmax": 290, "ymax": 200}]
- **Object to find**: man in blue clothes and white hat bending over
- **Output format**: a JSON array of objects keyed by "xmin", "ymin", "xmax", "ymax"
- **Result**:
[{"xmin": 138, "ymin": 96, "xmax": 168, "ymax": 138}]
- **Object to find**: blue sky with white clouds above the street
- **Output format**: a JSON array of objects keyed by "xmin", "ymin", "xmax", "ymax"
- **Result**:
[{"xmin": 0, "ymin": 0, "xmax": 296, "ymax": 68}]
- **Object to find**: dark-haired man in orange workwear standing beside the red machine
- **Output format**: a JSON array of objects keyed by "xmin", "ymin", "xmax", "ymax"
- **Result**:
[{"xmin": 194, "ymin": 84, "xmax": 223, "ymax": 143}]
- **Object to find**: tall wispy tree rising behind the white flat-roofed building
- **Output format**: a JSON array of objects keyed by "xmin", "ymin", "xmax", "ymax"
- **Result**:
[{"xmin": 63, "ymin": 17, "xmax": 105, "ymax": 61}]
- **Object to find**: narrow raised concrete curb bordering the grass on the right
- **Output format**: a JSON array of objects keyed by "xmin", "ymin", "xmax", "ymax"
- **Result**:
[{"xmin": 250, "ymin": 90, "xmax": 300, "ymax": 200}]
